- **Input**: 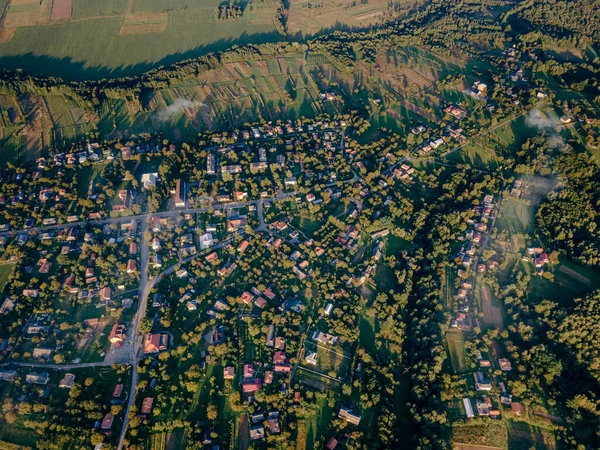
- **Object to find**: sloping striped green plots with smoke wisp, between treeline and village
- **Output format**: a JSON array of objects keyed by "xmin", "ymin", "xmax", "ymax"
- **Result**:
[{"xmin": 98, "ymin": 54, "xmax": 339, "ymax": 141}]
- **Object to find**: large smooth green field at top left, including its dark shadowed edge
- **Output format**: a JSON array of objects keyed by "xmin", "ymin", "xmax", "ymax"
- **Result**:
[{"xmin": 0, "ymin": 0, "xmax": 280, "ymax": 80}]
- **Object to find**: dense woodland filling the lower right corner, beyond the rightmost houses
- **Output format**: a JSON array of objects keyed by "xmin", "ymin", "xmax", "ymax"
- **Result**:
[{"xmin": 492, "ymin": 250, "xmax": 600, "ymax": 450}]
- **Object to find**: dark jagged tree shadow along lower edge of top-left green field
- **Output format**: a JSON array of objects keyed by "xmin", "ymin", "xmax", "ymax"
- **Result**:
[{"xmin": 0, "ymin": 31, "xmax": 282, "ymax": 81}]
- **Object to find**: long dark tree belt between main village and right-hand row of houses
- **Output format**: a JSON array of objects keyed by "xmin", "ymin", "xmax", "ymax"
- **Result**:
[{"xmin": 394, "ymin": 166, "xmax": 500, "ymax": 450}]
